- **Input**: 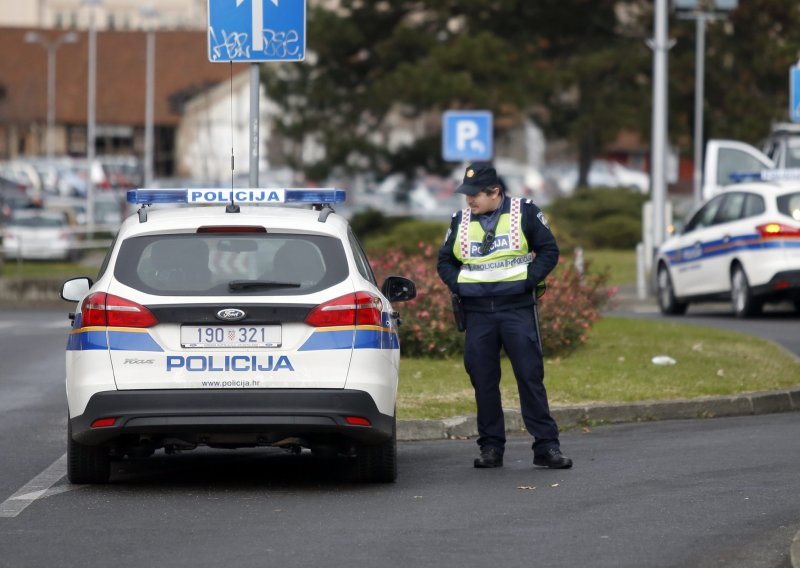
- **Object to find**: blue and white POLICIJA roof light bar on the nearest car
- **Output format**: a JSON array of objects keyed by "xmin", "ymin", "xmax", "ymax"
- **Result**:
[{"xmin": 127, "ymin": 187, "xmax": 347, "ymax": 205}]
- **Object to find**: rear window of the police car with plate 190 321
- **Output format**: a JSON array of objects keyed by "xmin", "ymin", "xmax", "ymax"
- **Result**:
[{"xmin": 114, "ymin": 233, "xmax": 348, "ymax": 297}]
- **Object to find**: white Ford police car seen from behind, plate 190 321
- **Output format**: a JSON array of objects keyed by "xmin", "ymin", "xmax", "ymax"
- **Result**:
[{"xmin": 61, "ymin": 189, "xmax": 416, "ymax": 483}]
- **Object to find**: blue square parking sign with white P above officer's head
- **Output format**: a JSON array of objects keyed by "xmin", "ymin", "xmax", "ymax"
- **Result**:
[{"xmin": 442, "ymin": 110, "xmax": 494, "ymax": 162}]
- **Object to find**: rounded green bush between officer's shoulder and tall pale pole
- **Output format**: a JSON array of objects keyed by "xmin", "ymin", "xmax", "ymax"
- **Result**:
[{"xmin": 547, "ymin": 187, "xmax": 647, "ymax": 251}]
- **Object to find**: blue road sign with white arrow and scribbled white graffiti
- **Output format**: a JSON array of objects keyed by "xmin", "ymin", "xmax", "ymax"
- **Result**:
[{"xmin": 208, "ymin": 0, "xmax": 306, "ymax": 63}]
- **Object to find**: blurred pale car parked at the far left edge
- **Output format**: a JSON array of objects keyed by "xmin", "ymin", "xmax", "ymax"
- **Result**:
[{"xmin": 2, "ymin": 209, "xmax": 80, "ymax": 260}]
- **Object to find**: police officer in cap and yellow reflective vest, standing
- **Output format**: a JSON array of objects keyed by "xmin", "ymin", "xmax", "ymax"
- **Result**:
[{"xmin": 437, "ymin": 162, "xmax": 572, "ymax": 469}]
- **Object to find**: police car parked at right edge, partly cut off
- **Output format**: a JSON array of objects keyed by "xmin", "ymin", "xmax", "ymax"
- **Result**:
[{"xmin": 656, "ymin": 178, "xmax": 800, "ymax": 317}]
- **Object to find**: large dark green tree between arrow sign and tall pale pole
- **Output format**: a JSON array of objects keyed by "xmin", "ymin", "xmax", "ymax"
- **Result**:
[{"xmin": 265, "ymin": 0, "xmax": 647, "ymax": 181}]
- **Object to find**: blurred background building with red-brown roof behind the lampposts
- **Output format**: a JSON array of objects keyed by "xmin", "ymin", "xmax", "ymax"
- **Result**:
[{"xmin": 0, "ymin": 27, "xmax": 248, "ymax": 176}]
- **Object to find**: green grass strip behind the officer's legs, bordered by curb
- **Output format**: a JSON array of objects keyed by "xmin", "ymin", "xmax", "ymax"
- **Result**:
[{"xmin": 397, "ymin": 316, "xmax": 800, "ymax": 419}]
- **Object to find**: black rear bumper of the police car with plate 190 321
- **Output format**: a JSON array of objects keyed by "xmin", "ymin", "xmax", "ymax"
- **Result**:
[{"xmin": 70, "ymin": 389, "xmax": 394, "ymax": 446}]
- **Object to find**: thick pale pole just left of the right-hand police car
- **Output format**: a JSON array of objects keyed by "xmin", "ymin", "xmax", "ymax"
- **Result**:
[{"xmin": 648, "ymin": 0, "xmax": 671, "ymax": 255}]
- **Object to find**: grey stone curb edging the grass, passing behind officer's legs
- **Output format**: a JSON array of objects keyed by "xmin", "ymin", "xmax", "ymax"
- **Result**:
[{"xmin": 397, "ymin": 388, "xmax": 800, "ymax": 442}]
